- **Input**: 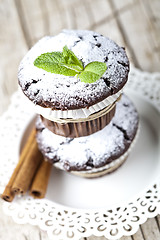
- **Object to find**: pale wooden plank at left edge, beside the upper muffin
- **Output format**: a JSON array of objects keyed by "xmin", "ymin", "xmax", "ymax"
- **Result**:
[{"xmin": 0, "ymin": 0, "xmax": 27, "ymax": 114}]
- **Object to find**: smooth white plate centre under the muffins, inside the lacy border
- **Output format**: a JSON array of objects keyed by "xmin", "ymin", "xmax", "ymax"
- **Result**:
[{"xmin": 42, "ymin": 91, "xmax": 160, "ymax": 209}]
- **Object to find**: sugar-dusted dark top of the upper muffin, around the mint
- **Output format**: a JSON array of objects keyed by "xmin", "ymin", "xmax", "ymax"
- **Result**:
[{"xmin": 18, "ymin": 30, "xmax": 129, "ymax": 110}]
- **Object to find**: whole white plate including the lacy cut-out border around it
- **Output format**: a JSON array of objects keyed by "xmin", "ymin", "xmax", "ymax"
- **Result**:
[{"xmin": 0, "ymin": 66, "xmax": 160, "ymax": 240}]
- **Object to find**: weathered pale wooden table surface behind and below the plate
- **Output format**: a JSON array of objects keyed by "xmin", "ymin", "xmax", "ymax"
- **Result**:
[{"xmin": 0, "ymin": 0, "xmax": 160, "ymax": 240}]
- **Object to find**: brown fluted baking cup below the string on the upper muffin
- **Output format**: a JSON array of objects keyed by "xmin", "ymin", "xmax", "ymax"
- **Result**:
[{"xmin": 41, "ymin": 104, "xmax": 116, "ymax": 138}]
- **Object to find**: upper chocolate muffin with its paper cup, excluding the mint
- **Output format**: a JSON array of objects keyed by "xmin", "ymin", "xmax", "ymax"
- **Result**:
[{"xmin": 18, "ymin": 30, "xmax": 129, "ymax": 137}]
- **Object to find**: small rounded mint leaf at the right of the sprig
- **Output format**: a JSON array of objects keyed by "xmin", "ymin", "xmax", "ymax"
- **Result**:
[{"xmin": 78, "ymin": 61, "xmax": 107, "ymax": 83}]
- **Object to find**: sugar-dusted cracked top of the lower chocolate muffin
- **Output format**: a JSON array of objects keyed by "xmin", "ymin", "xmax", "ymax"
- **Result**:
[{"xmin": 36, "ymin": 95, "xmax": 138, "ymax": 171}]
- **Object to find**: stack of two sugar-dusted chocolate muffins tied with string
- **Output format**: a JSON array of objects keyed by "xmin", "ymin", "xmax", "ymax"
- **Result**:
[{"xmin": 18, "ymin": 30, "xmax": 138, "ymax": 177}]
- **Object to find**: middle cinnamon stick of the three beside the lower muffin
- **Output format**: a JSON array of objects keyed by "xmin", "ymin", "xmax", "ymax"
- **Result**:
[{"xmin": 12, "ymin": 138, "xmax": 43, "ymax": 194}]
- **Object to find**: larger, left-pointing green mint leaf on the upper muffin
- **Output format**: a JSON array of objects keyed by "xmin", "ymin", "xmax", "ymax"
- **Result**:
[{"xmin": 34, "ymin": 52, "xmax": 79, "ymax": 76}]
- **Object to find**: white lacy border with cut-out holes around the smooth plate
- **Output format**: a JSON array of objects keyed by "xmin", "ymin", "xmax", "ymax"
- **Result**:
[{"xmin": 0, "ymin": 67, "xmax": 160, "ymax": 240}]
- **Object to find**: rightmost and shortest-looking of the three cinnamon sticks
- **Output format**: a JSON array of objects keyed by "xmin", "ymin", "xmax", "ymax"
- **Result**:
[{"xmin": 29, "ymin": 161, "xmax": 52, "ymax": 198}]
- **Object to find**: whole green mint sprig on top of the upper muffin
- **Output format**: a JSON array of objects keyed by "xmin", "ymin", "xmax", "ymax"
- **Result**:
[{"xmin": 34, "ymin": 46, "xmax": 107, "ymax": 83}]
